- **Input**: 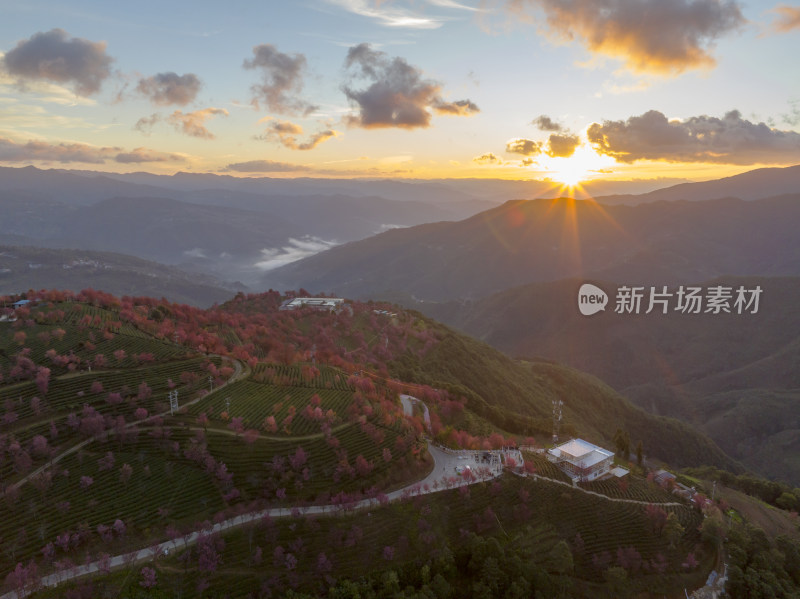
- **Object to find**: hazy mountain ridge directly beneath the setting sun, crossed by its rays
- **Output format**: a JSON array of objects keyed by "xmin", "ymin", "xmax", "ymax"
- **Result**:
[{"xmin": 264, "ymin": 193, "xmax": 800, "ymax": 301}]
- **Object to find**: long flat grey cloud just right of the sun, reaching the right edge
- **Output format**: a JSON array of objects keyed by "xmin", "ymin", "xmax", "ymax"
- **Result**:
[{"xmin": 587, "ymin": 110, "xmax": 800, "ymax": 165}]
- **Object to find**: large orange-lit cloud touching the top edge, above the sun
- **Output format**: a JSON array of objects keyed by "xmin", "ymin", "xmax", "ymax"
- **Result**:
[{"xmin": 506, "ymin": 0, "xmax": 746, "ymax": 75}]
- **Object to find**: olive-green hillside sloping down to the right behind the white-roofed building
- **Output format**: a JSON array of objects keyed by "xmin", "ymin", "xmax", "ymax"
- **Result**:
[{"xmin": 389, "ymin": 317, "xmax": 742, "ymax": 472}]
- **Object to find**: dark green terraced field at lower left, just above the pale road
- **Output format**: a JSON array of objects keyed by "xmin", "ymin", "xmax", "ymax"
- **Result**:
[{"xmin": 0, "ymin": 433, "xmax": 223, "ymax": 572}]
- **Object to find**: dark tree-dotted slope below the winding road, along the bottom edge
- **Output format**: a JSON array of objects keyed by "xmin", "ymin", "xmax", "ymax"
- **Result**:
[{"xmin": 28, "ymin": 476, "xmax": 713, "ymax": 598}]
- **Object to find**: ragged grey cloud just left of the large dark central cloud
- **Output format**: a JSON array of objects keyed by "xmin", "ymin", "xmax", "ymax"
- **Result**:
[{"xmin": 242, "ymin": 44, "xmax": 318, "ymax": 115}]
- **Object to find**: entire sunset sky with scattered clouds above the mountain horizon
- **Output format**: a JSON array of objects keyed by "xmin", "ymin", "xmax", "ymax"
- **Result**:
[{"xmin": 0, "ymin": 0, "xmax": 800, "ymax": 184}]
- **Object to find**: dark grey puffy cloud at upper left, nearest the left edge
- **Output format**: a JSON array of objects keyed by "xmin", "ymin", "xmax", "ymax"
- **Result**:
[{"xmin": 3, "ymin": 29, "xmax": 113, "ymax": 96}]
